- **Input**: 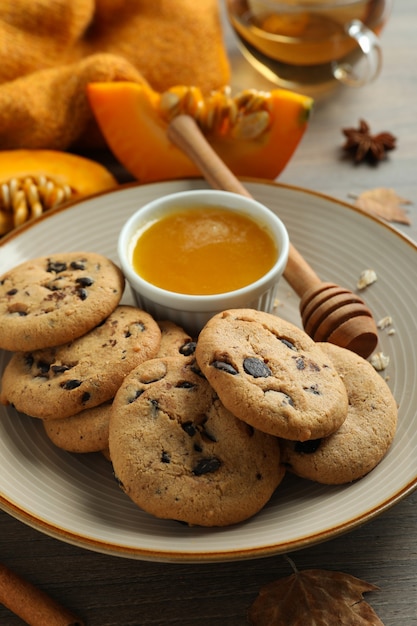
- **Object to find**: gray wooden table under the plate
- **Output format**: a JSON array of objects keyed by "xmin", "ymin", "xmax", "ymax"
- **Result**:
[{"xmin": 0, "ymin": 0, "xmax": 417, "ymax": 626}]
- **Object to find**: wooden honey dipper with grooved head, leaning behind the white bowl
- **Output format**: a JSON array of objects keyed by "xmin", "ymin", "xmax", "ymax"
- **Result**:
[{"xmin": 168, "ymin": 115, "xmax": 378, "ymax": 358}]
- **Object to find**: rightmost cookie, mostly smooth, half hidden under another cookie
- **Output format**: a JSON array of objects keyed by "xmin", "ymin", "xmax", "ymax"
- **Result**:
[{"xmin": 282, "ymin": 343, "xmax": 397, "ymax": 485}]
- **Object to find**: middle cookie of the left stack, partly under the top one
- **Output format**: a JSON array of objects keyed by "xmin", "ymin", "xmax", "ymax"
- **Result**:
[{"xmin": 0, "ymin": 305, "xmax": 161, "ymax": 419}]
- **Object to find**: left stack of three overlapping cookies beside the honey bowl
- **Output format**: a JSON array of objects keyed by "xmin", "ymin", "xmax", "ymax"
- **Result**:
[{"xmin": 0, "ymin": 252, "xmax": 161, "ymax": 452}]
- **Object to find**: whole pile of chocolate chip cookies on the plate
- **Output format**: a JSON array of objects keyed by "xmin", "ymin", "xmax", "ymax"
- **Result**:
[{"xmin": 0, "ymin": 252, "xmax": 397, "ymax": 526}]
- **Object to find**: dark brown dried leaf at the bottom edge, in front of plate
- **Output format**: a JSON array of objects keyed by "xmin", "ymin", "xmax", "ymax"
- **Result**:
[{"xmin": 248, "ymin": 569, "xmax": 384, "ymax": 626}]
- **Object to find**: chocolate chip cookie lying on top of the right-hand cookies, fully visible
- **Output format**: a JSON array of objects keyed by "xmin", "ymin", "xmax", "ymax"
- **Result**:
[{"xmin": 196, "ymin": 309, "xmax": 348, "ymax": 441}]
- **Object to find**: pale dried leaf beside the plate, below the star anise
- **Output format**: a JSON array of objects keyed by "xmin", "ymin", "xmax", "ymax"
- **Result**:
[{"xmin": 355, "ymin": 187, "xmax": 411, "ymax": 226}]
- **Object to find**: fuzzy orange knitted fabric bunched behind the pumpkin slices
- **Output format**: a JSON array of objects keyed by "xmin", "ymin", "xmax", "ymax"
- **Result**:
[{"xmin": 0, "ymin": 0, "xmax": 230, "ymax": 150}]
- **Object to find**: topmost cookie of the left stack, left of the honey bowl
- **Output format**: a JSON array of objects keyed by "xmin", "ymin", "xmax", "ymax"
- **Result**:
[{"xmin": 0, "ymin": 252, "xmax": 125, "ymax": 351}]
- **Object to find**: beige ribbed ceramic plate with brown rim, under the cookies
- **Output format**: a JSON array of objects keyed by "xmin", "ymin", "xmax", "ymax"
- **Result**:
[{"xmin": 0, "ymin": 180, "xmax": 417, "ymax": 561}]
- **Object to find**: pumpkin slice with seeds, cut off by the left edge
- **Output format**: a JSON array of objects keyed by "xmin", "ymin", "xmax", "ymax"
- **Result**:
[{"xmin": 0, "ymin": 150, "xmax": 117, "ymax": 235}]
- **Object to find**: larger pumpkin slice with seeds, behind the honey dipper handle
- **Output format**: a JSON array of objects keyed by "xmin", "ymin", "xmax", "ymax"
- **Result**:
[{"xmin": 87, "ymin": 82, "xmax": 313, "ymax": 183}]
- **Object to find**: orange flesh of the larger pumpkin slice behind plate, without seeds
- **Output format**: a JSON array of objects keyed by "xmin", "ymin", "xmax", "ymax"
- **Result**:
[{"xmin": 87, "ymin": 82, "xmax": 313, "ymax": 183}]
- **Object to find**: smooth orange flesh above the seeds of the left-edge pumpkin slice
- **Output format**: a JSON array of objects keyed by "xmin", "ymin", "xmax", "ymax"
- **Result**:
[{"xmin": 0, "ymin": 149, "xmax": 117, "ymax": 196}]
